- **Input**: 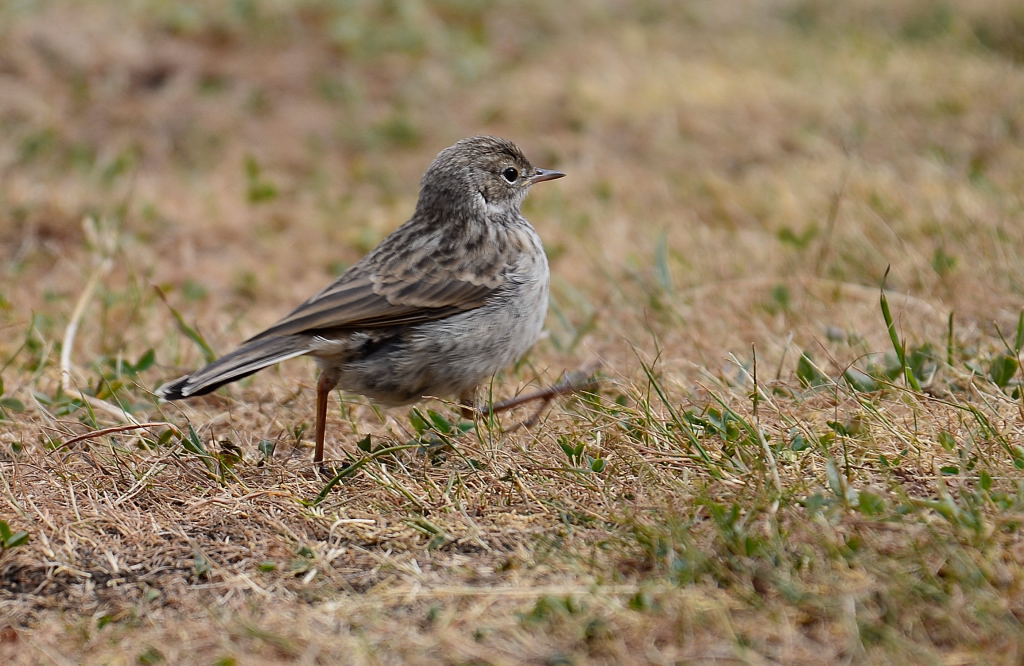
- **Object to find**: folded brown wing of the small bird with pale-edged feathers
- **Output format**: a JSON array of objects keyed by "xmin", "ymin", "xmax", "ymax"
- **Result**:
[{"xmin": 243, "ymin": 252, "xmax": 504, "ymax": 340}]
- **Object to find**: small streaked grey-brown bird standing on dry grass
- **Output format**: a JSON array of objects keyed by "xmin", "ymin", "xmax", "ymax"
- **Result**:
[{"xmin": 156, "ymin": 136, "xmax": 565, "ymax": 466}]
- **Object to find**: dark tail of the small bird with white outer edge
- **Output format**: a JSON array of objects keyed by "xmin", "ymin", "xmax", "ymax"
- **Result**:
[{"xmin": 156, "ymin": 335, "xmax": 310, "ymax": 400}]
